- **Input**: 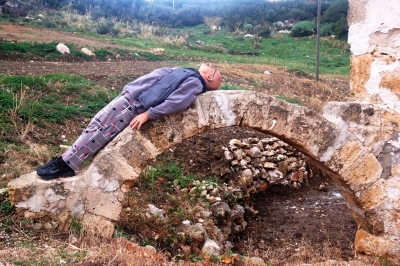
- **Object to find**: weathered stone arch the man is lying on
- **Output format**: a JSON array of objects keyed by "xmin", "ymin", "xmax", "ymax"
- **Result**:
[{"xmin": 9, "ymin": 91, "xmax": 400, "ymax": 257}]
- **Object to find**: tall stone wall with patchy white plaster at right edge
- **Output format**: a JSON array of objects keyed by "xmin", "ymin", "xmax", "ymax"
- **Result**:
[{"xmin": 348, "ymin": 0, "xmax": 400, "ymax": 259}]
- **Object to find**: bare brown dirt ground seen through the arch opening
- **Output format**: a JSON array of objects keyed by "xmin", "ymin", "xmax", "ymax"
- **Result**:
[{"xmin": 162, "ymin": 127, "xmax": 357, "ymax": 265}]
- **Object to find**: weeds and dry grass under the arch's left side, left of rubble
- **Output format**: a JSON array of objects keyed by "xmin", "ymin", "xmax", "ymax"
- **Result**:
[{"xmin": 118, "ymin": 157, "xmax": 228, "ymax": 259}]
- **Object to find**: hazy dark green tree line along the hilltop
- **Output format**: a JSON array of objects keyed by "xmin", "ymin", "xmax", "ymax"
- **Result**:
[{"xmin": 0, "ymin": 0, "xmax": 348, "ymax": 39}]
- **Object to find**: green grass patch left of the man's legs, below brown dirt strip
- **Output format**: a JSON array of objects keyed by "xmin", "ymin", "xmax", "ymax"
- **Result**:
[{"xmin": 0, "ymin": 74, "xmax": 119, "ymax": 133}]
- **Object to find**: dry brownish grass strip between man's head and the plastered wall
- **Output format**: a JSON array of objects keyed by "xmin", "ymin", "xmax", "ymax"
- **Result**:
[{"xmin": 216, "ymin": 64, "xmax": 351, "ymax": 113}]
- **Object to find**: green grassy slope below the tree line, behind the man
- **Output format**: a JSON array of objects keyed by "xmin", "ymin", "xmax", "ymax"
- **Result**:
[{"xmin": 0, "ymin": 13, "xmax": 350, "ymax": 75}]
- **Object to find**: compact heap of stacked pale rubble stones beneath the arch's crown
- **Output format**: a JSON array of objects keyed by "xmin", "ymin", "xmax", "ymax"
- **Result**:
[{"xmin": 223, "ymin": 137, "xmax": 309, "ymax": 202}]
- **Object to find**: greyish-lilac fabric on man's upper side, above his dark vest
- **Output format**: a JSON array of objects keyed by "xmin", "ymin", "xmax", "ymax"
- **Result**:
[{"xmin": 122, "ymin": 67, "xmax": 174, "ymax": 99}]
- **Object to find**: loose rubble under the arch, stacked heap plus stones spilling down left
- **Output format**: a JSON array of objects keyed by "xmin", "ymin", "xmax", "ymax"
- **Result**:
[{"xmin": 176, "ymin": 137, "xmax": 311, "ymax": 256}]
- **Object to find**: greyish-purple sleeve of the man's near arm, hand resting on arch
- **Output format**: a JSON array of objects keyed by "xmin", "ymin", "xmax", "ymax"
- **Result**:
[{"xmin": 147, "ymin": 77, "xmax": 203, "ymax": 120}]
